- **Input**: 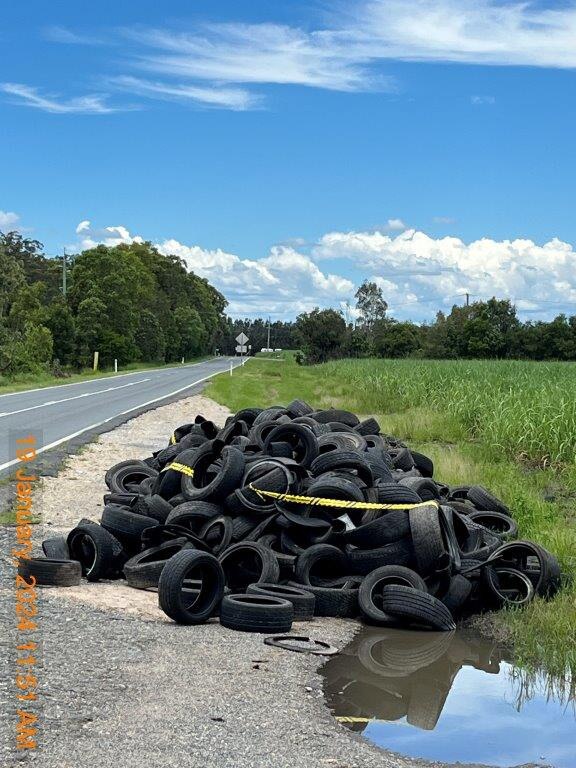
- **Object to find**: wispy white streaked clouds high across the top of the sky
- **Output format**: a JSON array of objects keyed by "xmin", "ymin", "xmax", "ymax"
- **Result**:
[{"xmin": 32, "ymin": 0, "xmax": 576, "ymax": 114}]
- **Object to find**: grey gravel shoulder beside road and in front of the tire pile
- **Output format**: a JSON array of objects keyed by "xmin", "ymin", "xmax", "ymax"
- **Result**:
[{"xmin": 0, "ymin": 396, "xmax": 436, "ymax": 768}]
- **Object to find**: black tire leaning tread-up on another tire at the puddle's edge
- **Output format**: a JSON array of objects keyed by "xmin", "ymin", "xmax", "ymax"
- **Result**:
[{"xmin": 382, "ymin": 585, "xmax": 456, "ymax": 632}]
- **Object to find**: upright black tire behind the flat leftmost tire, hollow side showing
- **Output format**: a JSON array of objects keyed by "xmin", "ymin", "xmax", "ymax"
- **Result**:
[{"xmin": 67, "ymin": 524, "xmax": 122, "ymax": 581}]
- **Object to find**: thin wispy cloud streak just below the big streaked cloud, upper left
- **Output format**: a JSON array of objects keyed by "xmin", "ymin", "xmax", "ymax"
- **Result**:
[{"xmin": 109, "ymin": 76, "xmax": 261, "ymax": 111}]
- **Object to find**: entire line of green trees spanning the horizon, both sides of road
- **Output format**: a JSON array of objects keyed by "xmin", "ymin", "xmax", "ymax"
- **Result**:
[{"xmin": 0, "ymin": 232, "xmax": 576, "ymax": 376}]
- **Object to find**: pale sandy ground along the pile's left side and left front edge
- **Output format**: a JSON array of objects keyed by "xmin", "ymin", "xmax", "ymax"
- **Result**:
[{"xmin": 34, "ymin": 395, "xmax": 230, "ymax": 621}]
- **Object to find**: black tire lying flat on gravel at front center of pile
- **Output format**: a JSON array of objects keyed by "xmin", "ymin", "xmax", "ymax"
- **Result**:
[{"xmin": 220, "ymin": 594, "xmax": 294, "ymax": 634}]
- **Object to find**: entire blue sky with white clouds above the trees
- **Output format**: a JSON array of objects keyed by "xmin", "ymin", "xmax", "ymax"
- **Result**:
[{"xmin": 0, "ymin": 0, "xmax": 576, "ymax": 320}]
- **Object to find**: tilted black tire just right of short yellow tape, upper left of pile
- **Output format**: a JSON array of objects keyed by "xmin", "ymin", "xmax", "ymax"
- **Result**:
[{"xmin": 181, "ymin": 440, "xmax": 245, "ymax": 502}]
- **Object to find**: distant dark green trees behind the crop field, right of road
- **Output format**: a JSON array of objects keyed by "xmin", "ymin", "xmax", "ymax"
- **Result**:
[{"xmin": 294, "ymin": 281, "xmax": 576, "ymax": 363}]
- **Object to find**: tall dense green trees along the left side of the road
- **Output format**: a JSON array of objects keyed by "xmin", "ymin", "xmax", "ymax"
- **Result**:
[{"xmin": 0, "ymin": 232, "xmax": 227, "ymax": 375}]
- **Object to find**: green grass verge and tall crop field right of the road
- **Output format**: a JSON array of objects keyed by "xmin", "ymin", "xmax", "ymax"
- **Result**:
[{"xmin": 207, "ymin": 355, "xmax": 576, "ymax": 676}]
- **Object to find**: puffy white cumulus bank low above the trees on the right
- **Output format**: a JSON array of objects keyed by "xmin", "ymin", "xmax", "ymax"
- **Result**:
[{"xmin": 313, "ymin": 230, "xmax": 576, "ymax": 317}]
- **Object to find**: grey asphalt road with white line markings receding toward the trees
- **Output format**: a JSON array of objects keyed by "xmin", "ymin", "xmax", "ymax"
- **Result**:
[{"xmin": 0, "ymin": 357, "xmax": 240, "ymax": 475}]
